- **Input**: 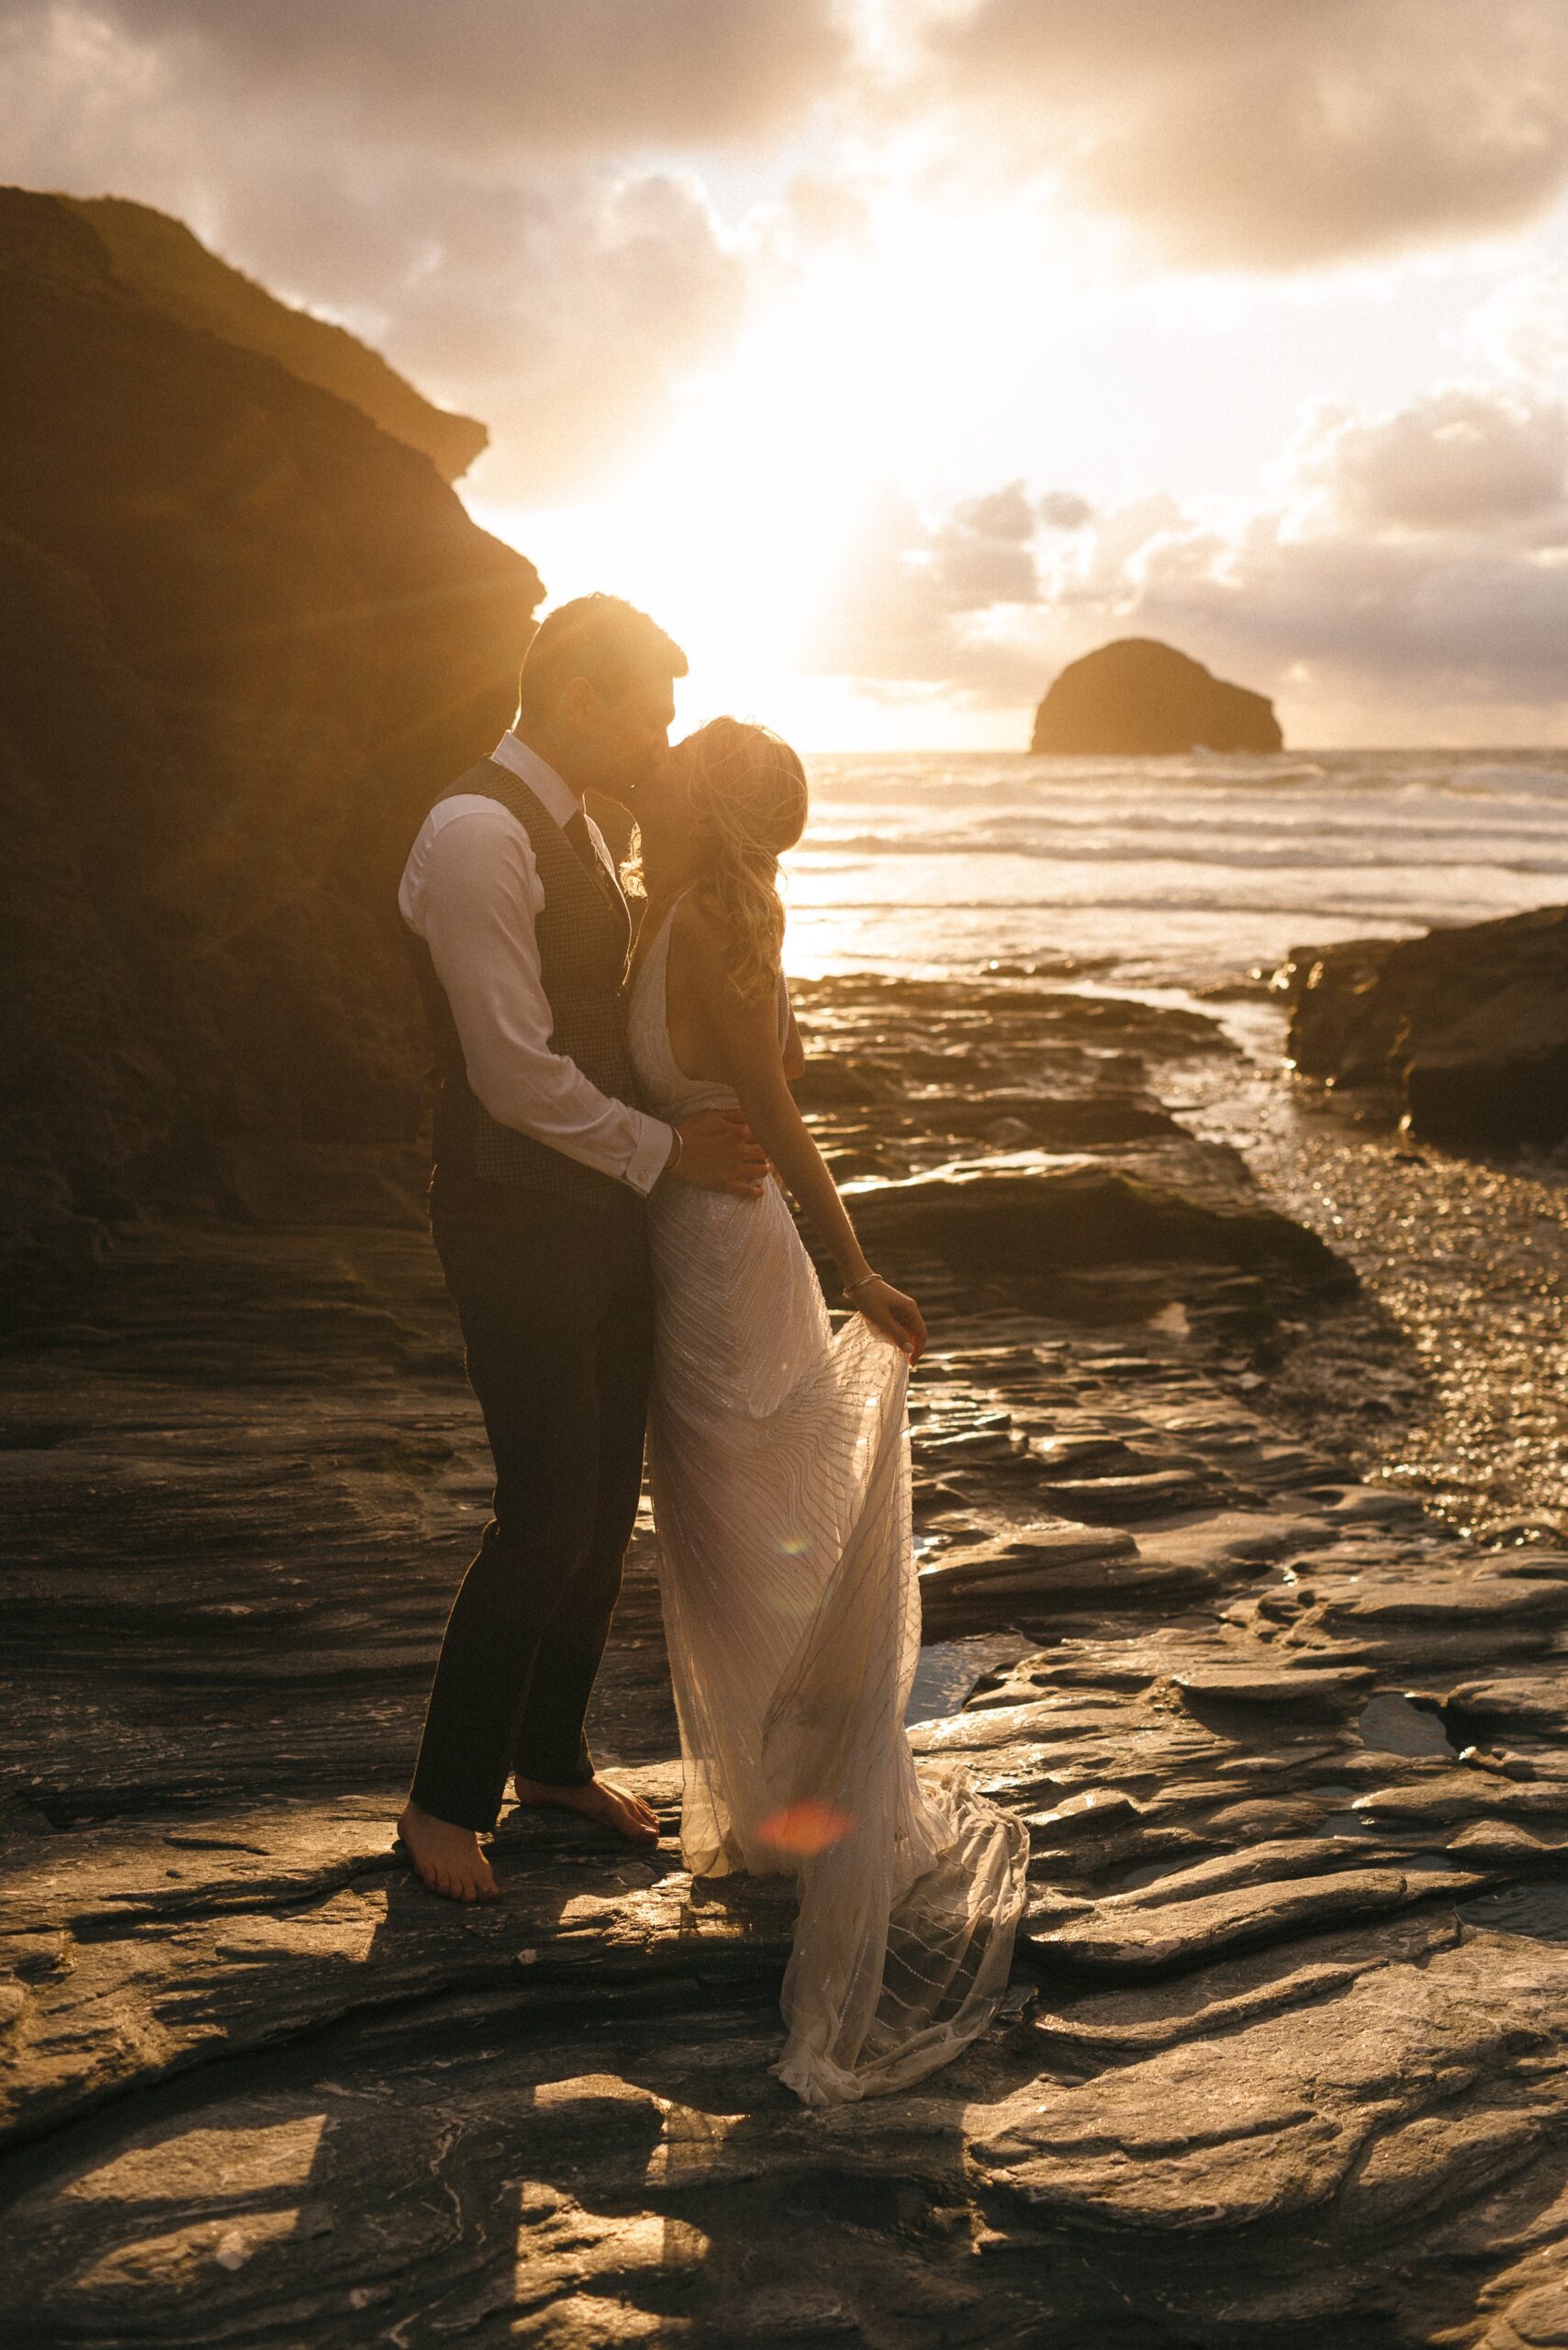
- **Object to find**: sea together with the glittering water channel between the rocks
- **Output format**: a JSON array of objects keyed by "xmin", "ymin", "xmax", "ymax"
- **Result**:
[{"xmin": 785, "ymin": 750, "xmax": 1568, "ymax": 1550}]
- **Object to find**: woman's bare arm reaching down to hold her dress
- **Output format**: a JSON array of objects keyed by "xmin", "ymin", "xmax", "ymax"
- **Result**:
[{"xmin": 687, "ymin": 910, "xmax": 926, "ymax": 1363}]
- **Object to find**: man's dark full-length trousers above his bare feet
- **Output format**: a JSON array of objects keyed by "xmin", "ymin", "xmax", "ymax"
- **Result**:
[{"xmin": 414, "ymin": 1175, "xmax": 654, "ymax": 1829}]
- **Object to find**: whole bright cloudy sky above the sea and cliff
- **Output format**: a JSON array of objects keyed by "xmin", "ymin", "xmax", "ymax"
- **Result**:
[{"xmin": 0, "ymin": 0, "xmax": 1568, "ymax": 747}]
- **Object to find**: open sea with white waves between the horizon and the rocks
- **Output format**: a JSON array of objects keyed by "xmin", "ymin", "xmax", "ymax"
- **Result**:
[{"xmin": 785, "ymin": 750, "xmax": 1568, "ymax": 991}]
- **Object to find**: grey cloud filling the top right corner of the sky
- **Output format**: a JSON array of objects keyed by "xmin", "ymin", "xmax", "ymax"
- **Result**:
[{"xmin": 928, "ymin": 0, "xmax": 1568, "ymax": 270}]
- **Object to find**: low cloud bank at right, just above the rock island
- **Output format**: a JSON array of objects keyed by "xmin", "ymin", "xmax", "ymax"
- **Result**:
[{"xmin": 823, "ymin": 357, "xmax": 1568, "ymax": 743}]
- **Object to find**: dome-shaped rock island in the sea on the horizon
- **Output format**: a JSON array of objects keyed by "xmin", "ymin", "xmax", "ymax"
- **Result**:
[{"xmin": 1030, "ymin": 637, "xmax": 1283, "ymax": 759}]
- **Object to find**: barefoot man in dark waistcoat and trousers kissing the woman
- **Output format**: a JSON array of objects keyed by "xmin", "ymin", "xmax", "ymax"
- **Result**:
[{"xmin": 398, "ymin": 595, "xmax": 767, "ymax": 1901}]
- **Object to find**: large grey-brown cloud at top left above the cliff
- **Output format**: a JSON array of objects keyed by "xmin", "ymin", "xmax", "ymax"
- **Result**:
[{"xmin": 0, "ymin": 0, "xmax": 844, "ymax": 503}]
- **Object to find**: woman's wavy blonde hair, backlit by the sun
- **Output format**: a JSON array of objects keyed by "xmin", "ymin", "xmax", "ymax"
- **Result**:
[{"xmin": 682, "ymin": 719, "xmax": 806, "ymax": 996}]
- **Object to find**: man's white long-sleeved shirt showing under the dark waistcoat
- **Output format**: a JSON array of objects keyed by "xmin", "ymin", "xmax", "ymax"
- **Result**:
[{"xmin": 398, "ymin": 733, "xmax": 675, "ymax": 1193}]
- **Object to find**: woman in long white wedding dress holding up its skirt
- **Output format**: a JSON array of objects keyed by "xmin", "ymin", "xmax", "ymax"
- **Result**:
[{"xmin": 628, "ymin": 719, "xmax": 1027, "ymax": 2106}]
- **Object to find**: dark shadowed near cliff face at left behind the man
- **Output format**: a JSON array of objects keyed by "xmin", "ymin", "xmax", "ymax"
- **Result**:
[{"xmin": 0, "ymin": 190, "xmax": 543, "ymax": 1311}]
